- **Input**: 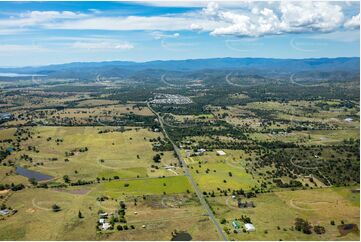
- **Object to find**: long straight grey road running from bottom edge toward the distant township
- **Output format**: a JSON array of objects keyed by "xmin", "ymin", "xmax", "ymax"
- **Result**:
[{"xmin": 147, "ymin": 102, "xmax": 228, "ymax": 241}]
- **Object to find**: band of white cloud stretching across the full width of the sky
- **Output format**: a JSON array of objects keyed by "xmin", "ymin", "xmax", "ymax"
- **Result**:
[{"xmin": 0, "ymin": 1, "xmax": 360, "ymax": 38}]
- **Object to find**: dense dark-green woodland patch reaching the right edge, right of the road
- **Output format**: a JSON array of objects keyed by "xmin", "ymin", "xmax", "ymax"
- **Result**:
[{"xmin": 255, "ymin": 142, "xmax": 360, "ymax": 187}]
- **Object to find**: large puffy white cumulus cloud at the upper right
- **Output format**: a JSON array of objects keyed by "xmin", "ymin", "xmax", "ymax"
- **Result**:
[{"xmin": 197, "ymin": 1, "xmax": 344, "ymax": 37}]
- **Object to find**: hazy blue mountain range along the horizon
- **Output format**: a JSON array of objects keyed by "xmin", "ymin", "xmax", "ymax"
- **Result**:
[{"xmin": 0, "ymin": 57, "xmax": 360, "ymax": 78}]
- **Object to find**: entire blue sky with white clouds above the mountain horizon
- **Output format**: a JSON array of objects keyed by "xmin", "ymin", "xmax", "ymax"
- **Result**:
[{"xmin": 0, "ymin": 0, "xmax": 360, "ymax": 66}]
